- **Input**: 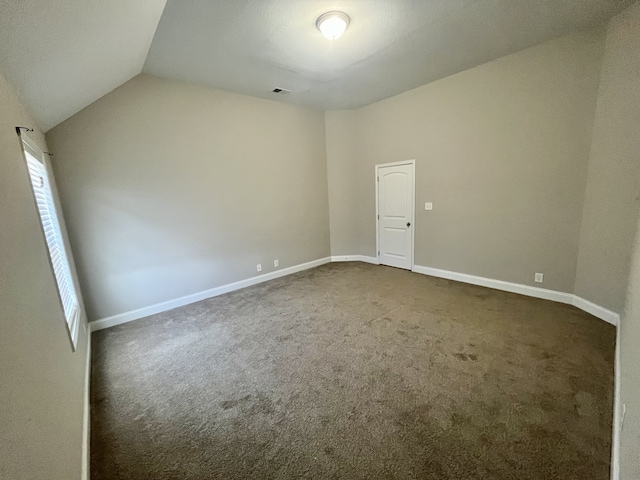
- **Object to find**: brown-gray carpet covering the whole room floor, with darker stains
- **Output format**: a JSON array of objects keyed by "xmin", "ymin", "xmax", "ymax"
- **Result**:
[{"xmin": 91, "ymin": 263, "xmax": 615, "ymax": 480}]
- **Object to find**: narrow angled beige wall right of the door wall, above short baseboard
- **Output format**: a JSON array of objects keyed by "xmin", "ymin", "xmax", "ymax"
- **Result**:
[{"xmin": 575, "ymin": 4, "xmax": 640, "ymax": 313}]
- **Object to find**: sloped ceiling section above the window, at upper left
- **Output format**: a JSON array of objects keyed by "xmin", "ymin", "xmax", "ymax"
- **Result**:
[{"xmin": 0, "ymin": 0, "xmax": 166, "ymax": 131}]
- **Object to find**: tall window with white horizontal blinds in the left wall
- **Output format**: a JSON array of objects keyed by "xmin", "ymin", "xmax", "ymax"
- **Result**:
[{"xmin": 21, "ymin": 134, "xmax": 80, "ymax": 350}]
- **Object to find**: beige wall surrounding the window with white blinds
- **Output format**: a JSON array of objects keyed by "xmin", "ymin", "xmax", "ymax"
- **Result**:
[{"xmin": 0, "ymin": 71, "xmax": 87, "ymax": 480}]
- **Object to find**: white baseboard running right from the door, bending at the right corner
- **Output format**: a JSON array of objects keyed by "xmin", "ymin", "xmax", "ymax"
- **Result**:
[{"xmin": 412, "ymin": 265, "xmax": 620, "ymax": 327}]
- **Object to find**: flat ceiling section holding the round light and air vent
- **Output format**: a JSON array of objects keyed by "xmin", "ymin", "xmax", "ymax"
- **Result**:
[{"xmin": 144, "ymin": 0, "xmax": 633, "ymax": 110}]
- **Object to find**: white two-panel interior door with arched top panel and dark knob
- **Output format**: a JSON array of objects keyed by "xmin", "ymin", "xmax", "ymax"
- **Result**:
[{"xmin": 376, "ymin": 162, "xmax": 415, "ymax": 270}]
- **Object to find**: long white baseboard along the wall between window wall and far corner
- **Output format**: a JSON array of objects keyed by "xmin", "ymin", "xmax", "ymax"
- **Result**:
[{"xmin": 89, "ymin": 257, "xmax": 331, "ymax": 332}]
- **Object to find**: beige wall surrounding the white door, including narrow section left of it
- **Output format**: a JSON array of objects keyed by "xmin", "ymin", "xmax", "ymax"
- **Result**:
[{"xmin": 326, "ymin": 30, "xmax": 603, "ymax": 292}]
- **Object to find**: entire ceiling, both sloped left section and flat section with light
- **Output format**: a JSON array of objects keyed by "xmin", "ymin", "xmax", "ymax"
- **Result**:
[{"xmin": 0, "ymin": 0, "xmax": 635, "ymax": 130}]
